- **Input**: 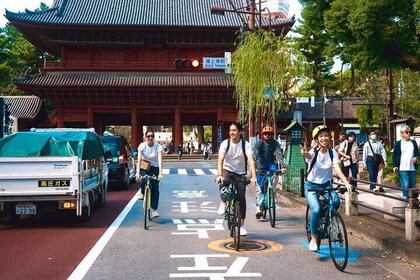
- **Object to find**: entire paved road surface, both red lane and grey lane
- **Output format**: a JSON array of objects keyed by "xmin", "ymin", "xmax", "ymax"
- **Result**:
[{"xmin": 0, "ymin": 161, "xmax": 419, "ymax": 280}]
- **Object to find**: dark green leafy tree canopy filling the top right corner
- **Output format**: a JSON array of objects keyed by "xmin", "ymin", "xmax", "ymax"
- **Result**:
[{"xmin": 324, "ymin": 0, "xmax": 420, "ymax": 71}]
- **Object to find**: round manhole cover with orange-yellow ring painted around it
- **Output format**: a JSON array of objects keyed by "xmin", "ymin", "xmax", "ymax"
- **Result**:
[{"xmin": 209, "ymin": 238, "xmax": 283, "ymax": 254}]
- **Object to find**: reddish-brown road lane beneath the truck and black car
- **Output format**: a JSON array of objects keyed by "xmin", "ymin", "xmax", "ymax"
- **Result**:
[{"xmin": 0, "ymin": 184, "xmax": 139, "ymax": 280}]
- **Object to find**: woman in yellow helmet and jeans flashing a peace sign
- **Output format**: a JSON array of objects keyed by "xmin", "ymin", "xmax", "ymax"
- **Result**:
[{"xmin": 301, "ymin": 125, "xmax": 351, "ymax": 252}]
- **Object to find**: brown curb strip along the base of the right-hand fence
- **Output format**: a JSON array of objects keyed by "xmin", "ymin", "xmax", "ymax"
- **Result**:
[{"xmin": 277, "ymin": 190, "xmax": 420, "ymax": 266}]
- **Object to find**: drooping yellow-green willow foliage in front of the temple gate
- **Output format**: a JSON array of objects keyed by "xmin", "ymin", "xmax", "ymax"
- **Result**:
[{"xmin": 232, "ymin": 30, "xmax": 309, "ymax": 124}]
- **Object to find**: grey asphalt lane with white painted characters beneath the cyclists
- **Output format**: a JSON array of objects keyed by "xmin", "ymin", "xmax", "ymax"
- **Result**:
[{"xmin": 75, "ymin": 172, "xmax": 416, "ymax": 279}]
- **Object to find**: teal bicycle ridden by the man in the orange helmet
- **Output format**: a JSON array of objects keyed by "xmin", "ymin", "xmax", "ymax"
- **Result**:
[{"xmin": 260, "ymin": 170, "xmax": 281, "ymax": 227}]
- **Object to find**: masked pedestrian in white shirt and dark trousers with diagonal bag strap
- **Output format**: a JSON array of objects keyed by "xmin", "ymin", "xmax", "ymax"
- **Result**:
[{"xmin": 363, "ymin": 131, "xmax": 386, "ymax": 192}]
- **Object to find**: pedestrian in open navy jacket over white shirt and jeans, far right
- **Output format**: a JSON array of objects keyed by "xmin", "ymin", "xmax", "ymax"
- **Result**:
[{"xmin": 392, "ymin": 126, "xmax": 419, "ymax": 198}]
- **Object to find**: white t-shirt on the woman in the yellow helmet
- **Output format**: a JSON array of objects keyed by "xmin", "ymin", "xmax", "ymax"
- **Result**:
[{"xmin": 305, "ymin": 149, "xmax": 340, "ymax": 184}]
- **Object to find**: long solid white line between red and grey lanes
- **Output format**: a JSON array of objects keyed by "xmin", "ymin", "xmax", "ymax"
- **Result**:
[{"xmin": 67, "ymin": 190, "xmax": 140, "ymax": 280}]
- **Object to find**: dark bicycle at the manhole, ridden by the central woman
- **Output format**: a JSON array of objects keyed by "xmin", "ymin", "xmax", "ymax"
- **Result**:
[{"xmin": 220, "ymin": 177, "xmax": 249, "ymax": 251}]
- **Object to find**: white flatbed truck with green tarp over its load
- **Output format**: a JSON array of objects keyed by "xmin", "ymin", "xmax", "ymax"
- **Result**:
[{"xmin": 0, "ymin": 128, "xmax": 108, "ymax": 222}]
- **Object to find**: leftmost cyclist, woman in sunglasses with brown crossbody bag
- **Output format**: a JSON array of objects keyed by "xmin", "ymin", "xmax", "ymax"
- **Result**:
[{"xmin": 136, "ymin": 129, "xmax": 163, "ymax": 218}]
